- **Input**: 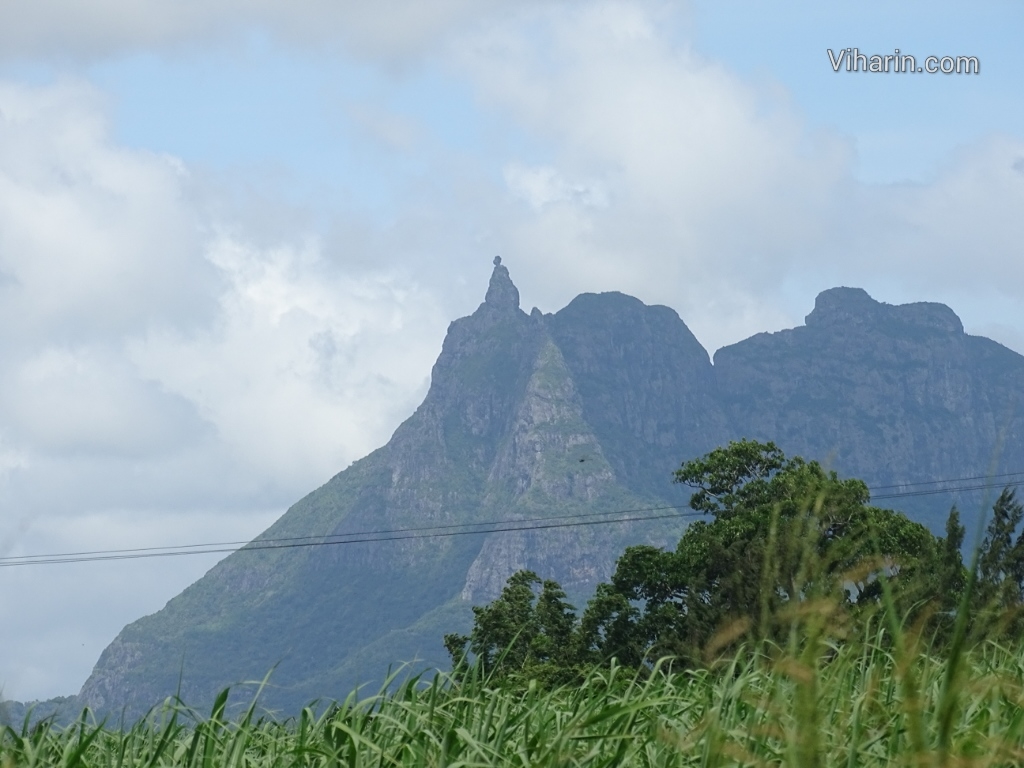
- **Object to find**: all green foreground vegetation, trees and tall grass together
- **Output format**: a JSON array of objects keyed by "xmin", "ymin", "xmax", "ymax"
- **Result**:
[{"xmin": 0, "ymin": 441, "xmax": 1024, "ymax": 768}]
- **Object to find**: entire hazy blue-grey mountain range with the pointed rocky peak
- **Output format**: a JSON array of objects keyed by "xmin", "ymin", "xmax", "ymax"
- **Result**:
[{"xmin": 79, "ymin": 260, "xmax": 1024, "ymax": 715}]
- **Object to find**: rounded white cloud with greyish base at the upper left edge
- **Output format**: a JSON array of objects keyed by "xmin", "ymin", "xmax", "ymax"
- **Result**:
[{"xmin": 0, "ymin": 82, "xmax": 214, "ymax": 340}]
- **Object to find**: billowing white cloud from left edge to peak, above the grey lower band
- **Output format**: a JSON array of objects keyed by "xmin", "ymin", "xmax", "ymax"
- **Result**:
[{"xmin": 0, "ymin": 78, "xmax": 445, "ymax": 492}]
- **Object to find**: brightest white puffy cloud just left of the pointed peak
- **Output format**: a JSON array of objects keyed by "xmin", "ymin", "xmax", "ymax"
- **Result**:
[{"xmin": 132, "ymin": 236, "xmax": 445, "ymax": 485}]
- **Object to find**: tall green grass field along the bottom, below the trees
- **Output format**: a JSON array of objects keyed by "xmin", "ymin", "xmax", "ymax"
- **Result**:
[{"xmin": 6, "ymin": 632, "xmax": 1024, "ymax": 768}]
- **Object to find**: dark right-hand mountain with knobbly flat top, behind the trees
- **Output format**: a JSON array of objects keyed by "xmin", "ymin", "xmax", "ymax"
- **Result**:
[{"xmin": 715, "ymin": 288, "xmax": 1024, "ymax": 530}]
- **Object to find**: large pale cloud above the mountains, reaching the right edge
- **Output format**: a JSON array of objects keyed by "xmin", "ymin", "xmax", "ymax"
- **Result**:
[{"xmin": 452, "ymin": 0, "xmax": 1024, "ymax": 351}]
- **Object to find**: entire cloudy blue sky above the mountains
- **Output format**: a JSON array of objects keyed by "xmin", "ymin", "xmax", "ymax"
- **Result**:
[{"xmin": 0, "ymin": 0, "xmax": 1024, "ymax": 699}]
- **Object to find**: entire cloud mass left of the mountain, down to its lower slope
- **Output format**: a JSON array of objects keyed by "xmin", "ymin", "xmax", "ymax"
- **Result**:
[{"xmin": 0, "ymin": 82, "xmax": 446, "ymax": 697}]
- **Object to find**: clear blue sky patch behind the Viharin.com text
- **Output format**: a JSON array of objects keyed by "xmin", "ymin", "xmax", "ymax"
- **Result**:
[{"xmin": 692, "ymin": 0, "xmax": 1024, "ymax": 182}]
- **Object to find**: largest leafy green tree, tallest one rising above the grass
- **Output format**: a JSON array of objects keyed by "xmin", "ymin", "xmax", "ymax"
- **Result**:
[{"xmin": 582, "ymin": 440, "xmax": 937, "ymax": 665}]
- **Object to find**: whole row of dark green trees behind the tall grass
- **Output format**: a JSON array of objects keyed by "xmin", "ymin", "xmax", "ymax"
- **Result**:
[{"xmin": 445, "ymin": 440, "xmax": 958, "ymax": 681}]
